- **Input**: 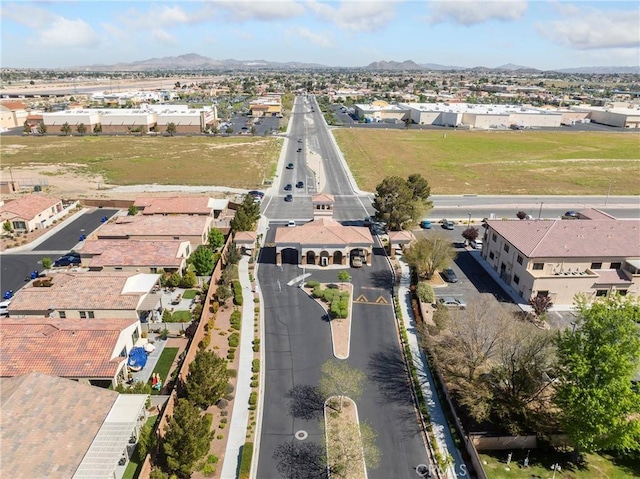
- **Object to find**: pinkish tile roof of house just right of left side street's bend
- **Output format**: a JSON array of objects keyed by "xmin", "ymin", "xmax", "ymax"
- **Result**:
[{"xmin": 80, "ymin": 239, "xmax": 185, "ymax": 268}]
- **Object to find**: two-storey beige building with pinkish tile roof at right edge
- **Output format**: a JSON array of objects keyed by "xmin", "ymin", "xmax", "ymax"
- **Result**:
[{"xmin": 482, "ymin": 214, "xmax": 640, "ymax": 306}]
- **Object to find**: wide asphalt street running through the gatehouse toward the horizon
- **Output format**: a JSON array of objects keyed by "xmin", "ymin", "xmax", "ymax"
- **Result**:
[{"xmin": 258, "ymin": 97, "xmax": 427, "ymax": 479}]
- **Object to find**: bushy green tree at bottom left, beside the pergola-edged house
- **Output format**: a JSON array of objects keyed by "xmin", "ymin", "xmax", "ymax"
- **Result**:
[{"xmin": 162, "ymin": 398, "xmax": 214, "ymax": 478}]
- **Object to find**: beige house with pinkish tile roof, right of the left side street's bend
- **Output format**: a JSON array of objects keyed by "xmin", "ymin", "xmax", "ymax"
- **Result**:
[{"xmin": 79, "ymin": 239, "xmax": 191, "ymax": 274}]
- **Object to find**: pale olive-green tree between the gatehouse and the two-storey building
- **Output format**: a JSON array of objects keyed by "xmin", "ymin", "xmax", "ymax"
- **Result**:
[{"xmin": 404, "ymin": 233, "xmax": 456, "ymax": 279}]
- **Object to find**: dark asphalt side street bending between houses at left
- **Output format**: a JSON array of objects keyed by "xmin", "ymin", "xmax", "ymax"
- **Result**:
[{"xmin": 0, "ymin": 209, "xmax": 118, "ymax": 294}]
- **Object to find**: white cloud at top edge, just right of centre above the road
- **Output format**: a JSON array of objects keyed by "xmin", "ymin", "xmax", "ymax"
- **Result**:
[{"xmin": 306, "ymin": 1, "xmax": 397, "ymax": 32}]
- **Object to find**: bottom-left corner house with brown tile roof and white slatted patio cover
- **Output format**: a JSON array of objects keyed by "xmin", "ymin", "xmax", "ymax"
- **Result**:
[{"xmin": 0, "ymin": 372, "xmax": 148, "ymax": 479}]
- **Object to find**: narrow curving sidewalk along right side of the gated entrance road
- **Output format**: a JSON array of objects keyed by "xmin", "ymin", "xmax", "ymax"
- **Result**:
[{"xmin": 398, "ymin": 258, "xmax": 465, "ymax": 479}]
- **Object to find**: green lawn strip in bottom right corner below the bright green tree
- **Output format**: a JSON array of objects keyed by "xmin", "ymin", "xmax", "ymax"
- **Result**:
[{"xmin": 480, "ymin": 450, "xmax": 640, "ymax": 479}]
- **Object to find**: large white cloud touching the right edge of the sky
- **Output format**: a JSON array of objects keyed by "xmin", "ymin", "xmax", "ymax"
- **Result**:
[{"xmin": 537, "ymin": 7, "xmax": 640, "ymax": 50}]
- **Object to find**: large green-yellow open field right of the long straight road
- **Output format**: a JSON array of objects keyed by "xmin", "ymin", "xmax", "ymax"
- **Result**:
[{"xmin": 333, "ymin": 128, "xmax": 640, "ymax": 195}]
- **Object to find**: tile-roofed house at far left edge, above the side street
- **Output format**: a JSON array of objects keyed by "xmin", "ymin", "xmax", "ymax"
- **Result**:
[{"xmin": 0, "ymin": 193, "xmax": 64, "ymax": 231}]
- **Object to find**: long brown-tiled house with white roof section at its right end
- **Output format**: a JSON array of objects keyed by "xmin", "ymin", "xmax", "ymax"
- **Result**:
[{"xmin": 8, "ymin": 272, "xmax": 160, "ymax": 320}]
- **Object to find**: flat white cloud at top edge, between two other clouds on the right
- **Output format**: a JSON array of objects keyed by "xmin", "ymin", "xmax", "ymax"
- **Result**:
[{"xmin": 429, "ymin": 0, "xmax": 527, "ymax": 26}]
